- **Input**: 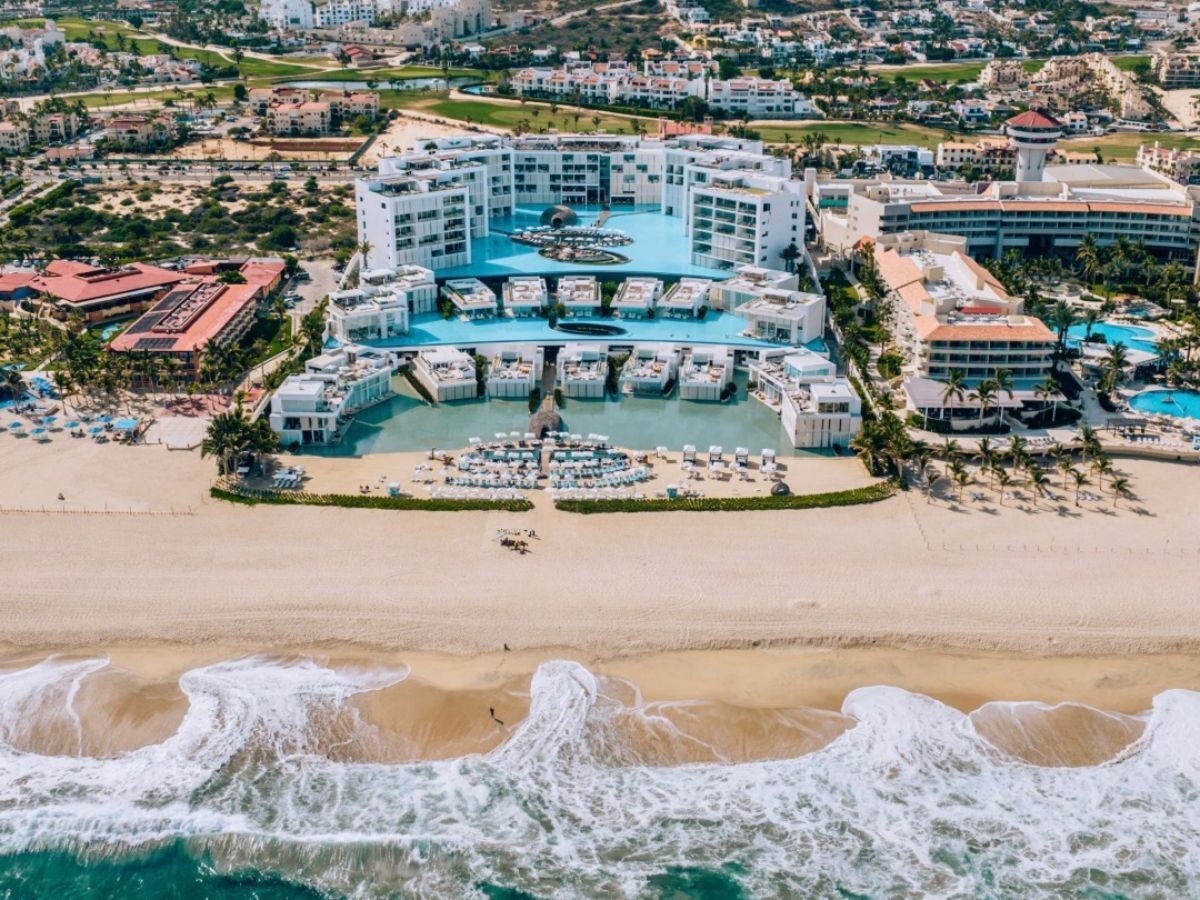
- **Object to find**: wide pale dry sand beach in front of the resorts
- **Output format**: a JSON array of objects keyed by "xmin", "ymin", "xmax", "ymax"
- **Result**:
[{"xmin": 0, "ymin": 427, "xmax": 1200, "ymax": 655}]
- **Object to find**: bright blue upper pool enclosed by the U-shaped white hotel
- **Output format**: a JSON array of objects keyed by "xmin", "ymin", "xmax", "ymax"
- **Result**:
[{"xmin": 438, "ymin": 205, "xmax": 724, "ymax": 278}]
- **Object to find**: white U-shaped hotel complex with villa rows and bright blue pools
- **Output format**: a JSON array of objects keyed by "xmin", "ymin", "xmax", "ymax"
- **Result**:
[{"xmin": 272, "ymin": 134, "xmax": 858, "ymax": 446}]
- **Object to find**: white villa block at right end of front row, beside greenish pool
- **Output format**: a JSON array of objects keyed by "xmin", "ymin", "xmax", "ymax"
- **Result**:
[{"xmin": 750, "ymin": 349, "xmax": 863, "ymax": 448}]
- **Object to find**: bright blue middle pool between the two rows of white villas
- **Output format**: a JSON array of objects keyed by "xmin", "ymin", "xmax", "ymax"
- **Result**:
[{"xmin": 364, "ymin": 311, "xmax": 826, "ymax": 352}]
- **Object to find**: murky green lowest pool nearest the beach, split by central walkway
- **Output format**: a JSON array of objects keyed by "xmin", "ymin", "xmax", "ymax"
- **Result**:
[{"xmin": 305, "ymin": 372, "xmax": 793, "ymax": 456}]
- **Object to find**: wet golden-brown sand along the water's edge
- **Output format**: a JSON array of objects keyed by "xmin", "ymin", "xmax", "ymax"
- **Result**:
[{"xmin": 0, "ymin": 646, "xmax": 1200, "ymax": 766}]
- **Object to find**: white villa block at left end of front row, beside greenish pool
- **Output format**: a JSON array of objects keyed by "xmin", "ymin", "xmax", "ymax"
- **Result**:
[{"xmin": 268, "ymin": 344, "xmax": 396, "ymax": 445}]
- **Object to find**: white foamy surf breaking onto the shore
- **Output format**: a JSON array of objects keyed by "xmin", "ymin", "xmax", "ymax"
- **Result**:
[{"xmin": 0, "ymin": 659, "xmax": 1200, "ymax": 898}]
